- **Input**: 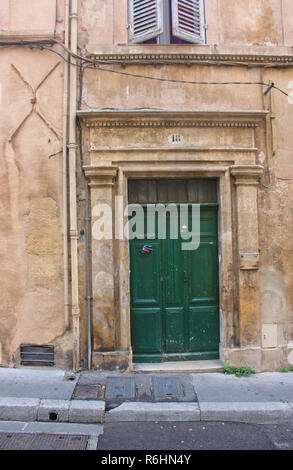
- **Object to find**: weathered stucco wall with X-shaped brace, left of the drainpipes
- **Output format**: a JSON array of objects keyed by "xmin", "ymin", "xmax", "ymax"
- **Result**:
[{"xmin": 0, "ymin": 0, "xmax": 72, "ymax": 367}]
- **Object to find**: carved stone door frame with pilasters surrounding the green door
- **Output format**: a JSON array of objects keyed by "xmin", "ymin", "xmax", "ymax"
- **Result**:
[{"xmin": 79, "ymin": 112, "xmax": 265, "ymax": 369}]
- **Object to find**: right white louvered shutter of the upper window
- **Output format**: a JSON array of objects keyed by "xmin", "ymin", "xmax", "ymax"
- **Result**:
[{"xmin": 172, "ymin": 0, "xmax": 205, "ymax": 44}]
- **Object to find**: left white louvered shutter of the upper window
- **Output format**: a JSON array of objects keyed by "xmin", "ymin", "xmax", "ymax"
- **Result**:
[{"xmin": 129, "ymin": 0, "xmax": 164, "ymax": 43}]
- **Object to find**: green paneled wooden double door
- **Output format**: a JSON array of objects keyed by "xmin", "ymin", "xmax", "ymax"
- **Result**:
[{"xmin": 130, "ymin": 198, "xmax": 219, "ymax": 362}]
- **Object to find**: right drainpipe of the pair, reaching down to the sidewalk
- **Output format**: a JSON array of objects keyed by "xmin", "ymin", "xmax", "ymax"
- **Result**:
[{"xmin": 68, "ymin": 0, "xmax": 80, "ymax": 371}]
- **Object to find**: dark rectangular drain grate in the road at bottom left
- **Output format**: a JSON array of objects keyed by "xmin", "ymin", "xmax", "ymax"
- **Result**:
[{"xmin": 0, "ymin": 433, "xmax": 89, "ymax": 450}]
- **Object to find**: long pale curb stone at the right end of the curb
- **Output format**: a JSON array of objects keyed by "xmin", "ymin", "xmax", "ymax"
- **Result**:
[{"xmin": 199, "ymin": 402, "xmax": 292, "ymax": 424}]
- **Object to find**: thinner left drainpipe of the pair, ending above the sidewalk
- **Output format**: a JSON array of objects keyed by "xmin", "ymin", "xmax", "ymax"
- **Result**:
[{"xmin": 62, "ymin": 0, "xmax": 69, "ymax": 330}]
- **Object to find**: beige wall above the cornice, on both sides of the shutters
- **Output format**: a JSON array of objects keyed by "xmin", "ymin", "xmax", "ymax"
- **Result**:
[{"xmin": 80, "ymin": 0, "xmax": 293, "ymax": 50}]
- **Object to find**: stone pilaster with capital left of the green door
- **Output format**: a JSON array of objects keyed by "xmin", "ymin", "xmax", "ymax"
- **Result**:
[{"xmin": 84, "ymin": 166, "xmax": 117, "ymax": 351}]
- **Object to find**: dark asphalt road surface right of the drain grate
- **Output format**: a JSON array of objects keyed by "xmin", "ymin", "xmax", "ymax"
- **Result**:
[{"xmin": 97, "ymin": 422, "xmax": 293, "ymax": 451}]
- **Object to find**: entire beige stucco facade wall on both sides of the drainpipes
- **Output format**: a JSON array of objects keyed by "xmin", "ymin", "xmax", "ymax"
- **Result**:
[{"xmin": 0, "ymin": 0, "xmax": 293, "ymax": 368}]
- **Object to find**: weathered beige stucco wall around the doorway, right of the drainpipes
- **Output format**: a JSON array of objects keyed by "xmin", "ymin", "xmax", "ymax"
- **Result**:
[{"xmin": 80, "ymin": 0, "xmax": 293, "ymax": 370}]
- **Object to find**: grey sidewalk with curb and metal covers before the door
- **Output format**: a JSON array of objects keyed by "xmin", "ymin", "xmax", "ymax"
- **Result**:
[{"xmin": 0, "ymin": 368, "xmax": 293, "ymax": 424}]
